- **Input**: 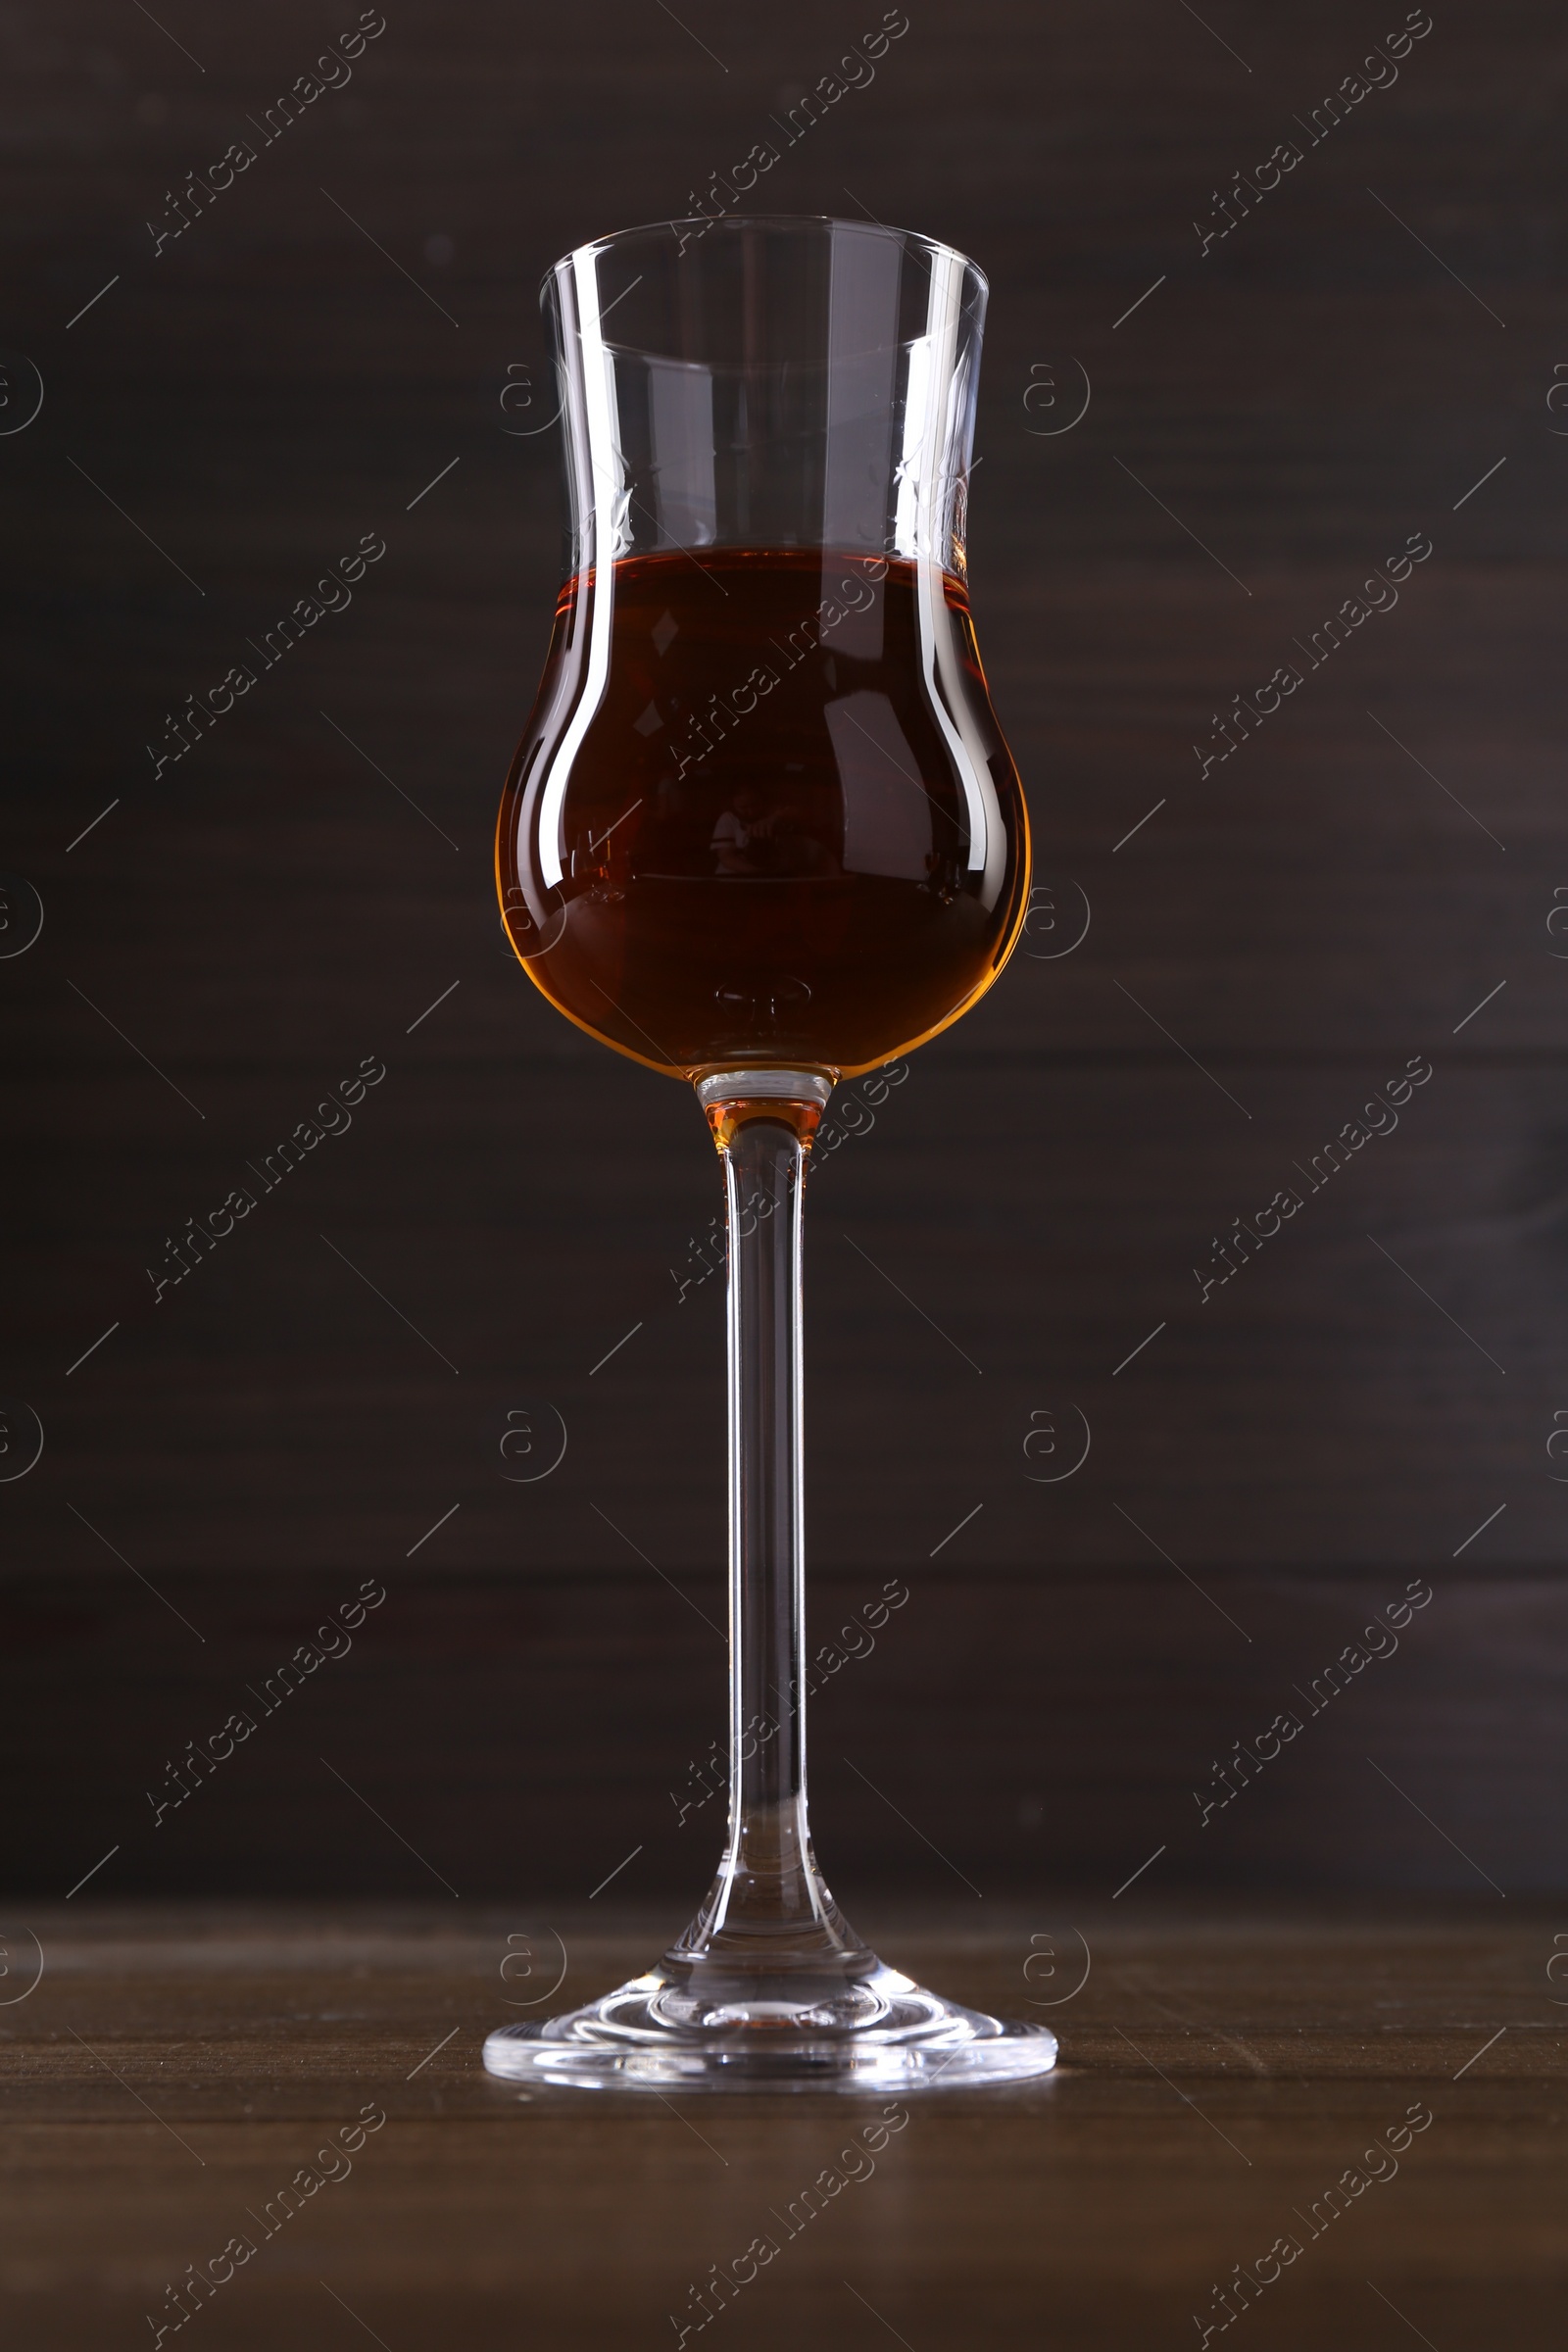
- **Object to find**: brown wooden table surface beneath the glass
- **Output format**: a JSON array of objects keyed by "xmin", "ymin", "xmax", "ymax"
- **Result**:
[{"xmin": 0, "ymin": 1893, "xmax": 1568, "ymax": 2352}]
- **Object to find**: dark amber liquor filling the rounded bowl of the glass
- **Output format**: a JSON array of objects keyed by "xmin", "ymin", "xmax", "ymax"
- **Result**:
[{"xmin": 499, "ymin": 548, "xmax": 1027, "ymax": 1075}]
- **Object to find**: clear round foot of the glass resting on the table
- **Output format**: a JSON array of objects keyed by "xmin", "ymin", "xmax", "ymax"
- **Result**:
[{"xmin": 484, "ymin": 1952, "xmax": 1055, "ymax": 2091}]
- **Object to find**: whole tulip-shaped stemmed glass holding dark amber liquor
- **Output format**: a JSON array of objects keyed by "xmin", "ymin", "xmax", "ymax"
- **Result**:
[{"xmin": 484, "ymin": 217, "xmax": 1055, "ymax": 2091}]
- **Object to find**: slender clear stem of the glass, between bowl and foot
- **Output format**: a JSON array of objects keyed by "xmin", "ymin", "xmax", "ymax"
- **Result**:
[{"xmin": 684, "ymin": 1072, "xmax": 862, "ymax": 1969}]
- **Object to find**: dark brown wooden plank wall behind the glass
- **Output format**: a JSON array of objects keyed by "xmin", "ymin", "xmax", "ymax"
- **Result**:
[{"xmin": 0, "ymin": 0, "xmax": 1568, "ymax": 1919}]
